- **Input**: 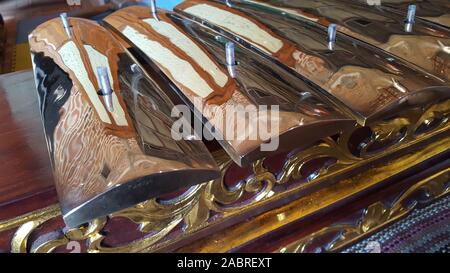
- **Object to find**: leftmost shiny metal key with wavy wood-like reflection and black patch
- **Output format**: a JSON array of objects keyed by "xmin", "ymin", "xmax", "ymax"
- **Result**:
[{"xmin": 29, "ymin": 15, "xmax": 219, "ymax": 226}]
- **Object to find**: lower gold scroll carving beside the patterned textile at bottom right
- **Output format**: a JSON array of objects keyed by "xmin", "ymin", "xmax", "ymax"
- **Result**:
[{"xmin": 279, "ymin": 168, "xmax": 450, "ymax": 253}]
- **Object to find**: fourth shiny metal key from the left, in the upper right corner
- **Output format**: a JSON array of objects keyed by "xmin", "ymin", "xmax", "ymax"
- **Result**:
[{"xmin": 236, "ymin": 0, "xmax": 450, "ymax": 81}]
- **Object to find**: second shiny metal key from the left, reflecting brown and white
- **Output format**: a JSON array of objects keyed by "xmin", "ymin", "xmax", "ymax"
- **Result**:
[{"xmin": 105, "ymin": 7, "xmax": 354, "ymax": 165}]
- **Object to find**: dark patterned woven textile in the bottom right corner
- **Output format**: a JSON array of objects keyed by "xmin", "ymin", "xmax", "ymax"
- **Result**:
[{"xmin": 342, "ymin": 195, "xmax": 450, "ymax": 253}]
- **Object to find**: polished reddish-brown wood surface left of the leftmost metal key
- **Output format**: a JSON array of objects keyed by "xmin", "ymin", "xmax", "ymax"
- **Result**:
[{"xmin": 0, "ymin": 71, "xmax": 54, "ymax": 219}]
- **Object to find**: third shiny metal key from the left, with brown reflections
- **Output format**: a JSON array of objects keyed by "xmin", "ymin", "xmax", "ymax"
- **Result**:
[{"xmin": 175, "ymin": 0, "xmax": 450, "ymax": 125}]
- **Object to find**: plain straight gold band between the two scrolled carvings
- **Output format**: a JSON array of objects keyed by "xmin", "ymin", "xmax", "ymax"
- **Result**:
[{"xmin": 173, "ymin": 135, "xmax": 450, "ymax": 252}]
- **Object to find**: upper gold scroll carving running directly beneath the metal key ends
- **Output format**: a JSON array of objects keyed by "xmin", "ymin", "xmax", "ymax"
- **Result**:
[{"xmin": 4, "ymin": 100, "xmax": 450, "ymax": 252}]
